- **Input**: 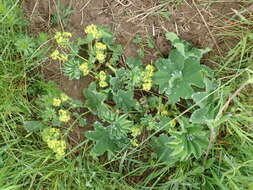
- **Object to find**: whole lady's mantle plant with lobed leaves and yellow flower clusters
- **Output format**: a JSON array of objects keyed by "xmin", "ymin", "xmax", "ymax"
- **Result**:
[{"xmin": 29, "ymin": 25, "xmax": 219, "ymax": 165}]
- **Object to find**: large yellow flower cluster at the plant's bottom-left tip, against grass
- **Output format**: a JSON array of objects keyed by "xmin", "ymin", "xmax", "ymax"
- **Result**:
[{"xmin": 42, "ymin": 128, "xmax": 67, "ymax": 160}]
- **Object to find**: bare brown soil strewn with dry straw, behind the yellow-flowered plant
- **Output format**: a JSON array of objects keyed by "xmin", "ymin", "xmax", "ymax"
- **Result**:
[{"xmin": 23, "ymin": 0, "xmax": 245, "ymax": 100}]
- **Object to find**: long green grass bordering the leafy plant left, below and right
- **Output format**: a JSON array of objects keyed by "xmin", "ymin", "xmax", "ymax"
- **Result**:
[{"xmin": 0, "ymin": 1, "xmax": 253, "ymax": 190}]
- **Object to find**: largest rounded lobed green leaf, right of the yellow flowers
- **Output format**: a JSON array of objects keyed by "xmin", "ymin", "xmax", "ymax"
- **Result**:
[{"xmin": 154, "ymin": 53, "xmax": 204, "ymax": 104}]
